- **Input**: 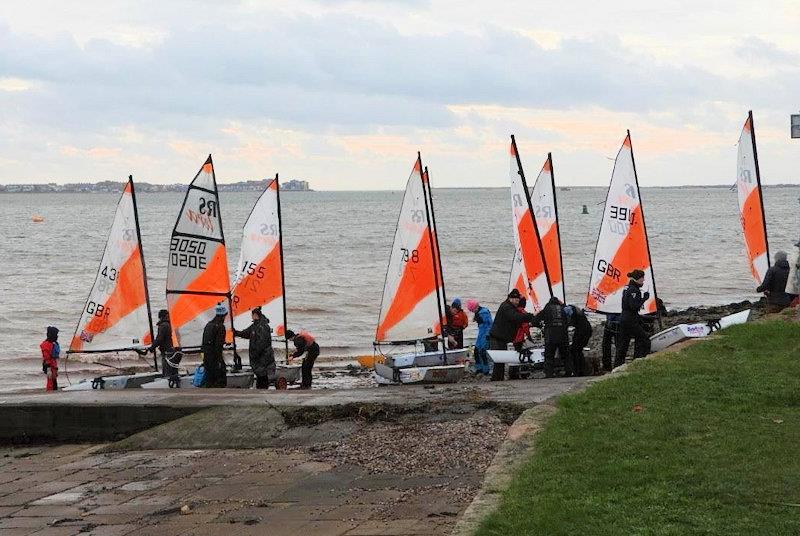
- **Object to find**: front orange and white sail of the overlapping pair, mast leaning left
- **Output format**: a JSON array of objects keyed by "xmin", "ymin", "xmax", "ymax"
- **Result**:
[{"xmin": 508, "ymin": 135, "xmax": 560, "ymax": 312}]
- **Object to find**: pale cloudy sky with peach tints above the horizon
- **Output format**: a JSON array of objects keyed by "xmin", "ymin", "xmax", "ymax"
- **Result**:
[{"xmin": 0, "ymin": 0, "xmax": 800, "ymax": 190}]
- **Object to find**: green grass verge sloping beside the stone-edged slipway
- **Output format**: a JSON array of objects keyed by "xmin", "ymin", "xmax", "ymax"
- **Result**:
[{"xmin": 477, "ymin": 321, "xmax": 800, "ymax": 536}]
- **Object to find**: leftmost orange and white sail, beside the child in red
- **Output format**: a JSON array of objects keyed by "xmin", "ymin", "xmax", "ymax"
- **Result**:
[{"xmin": 69, "ymin": 177, "xmax": 153, "ymax": 353}]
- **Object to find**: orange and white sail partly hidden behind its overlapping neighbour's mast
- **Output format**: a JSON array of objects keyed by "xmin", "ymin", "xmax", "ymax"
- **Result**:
[{"xmin": 531, "ymin": 153, "xmax": 566, "ymax": 303}]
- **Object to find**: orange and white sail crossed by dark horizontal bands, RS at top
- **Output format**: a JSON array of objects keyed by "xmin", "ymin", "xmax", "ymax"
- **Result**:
[{"xmin": 167, "ymin": 155, "xmax": 231, "ymax": 350}]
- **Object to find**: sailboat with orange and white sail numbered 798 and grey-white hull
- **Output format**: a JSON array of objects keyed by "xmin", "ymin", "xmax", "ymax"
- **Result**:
[{"xmin": 374, "ymin": 153, "xmax": 466, "ymax": 383}]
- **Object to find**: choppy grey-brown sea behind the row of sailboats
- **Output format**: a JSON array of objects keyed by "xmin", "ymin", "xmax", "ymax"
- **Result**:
[{"xmin": 0, "ymin": 186, "xmax": 800, "ymax": 391}]
